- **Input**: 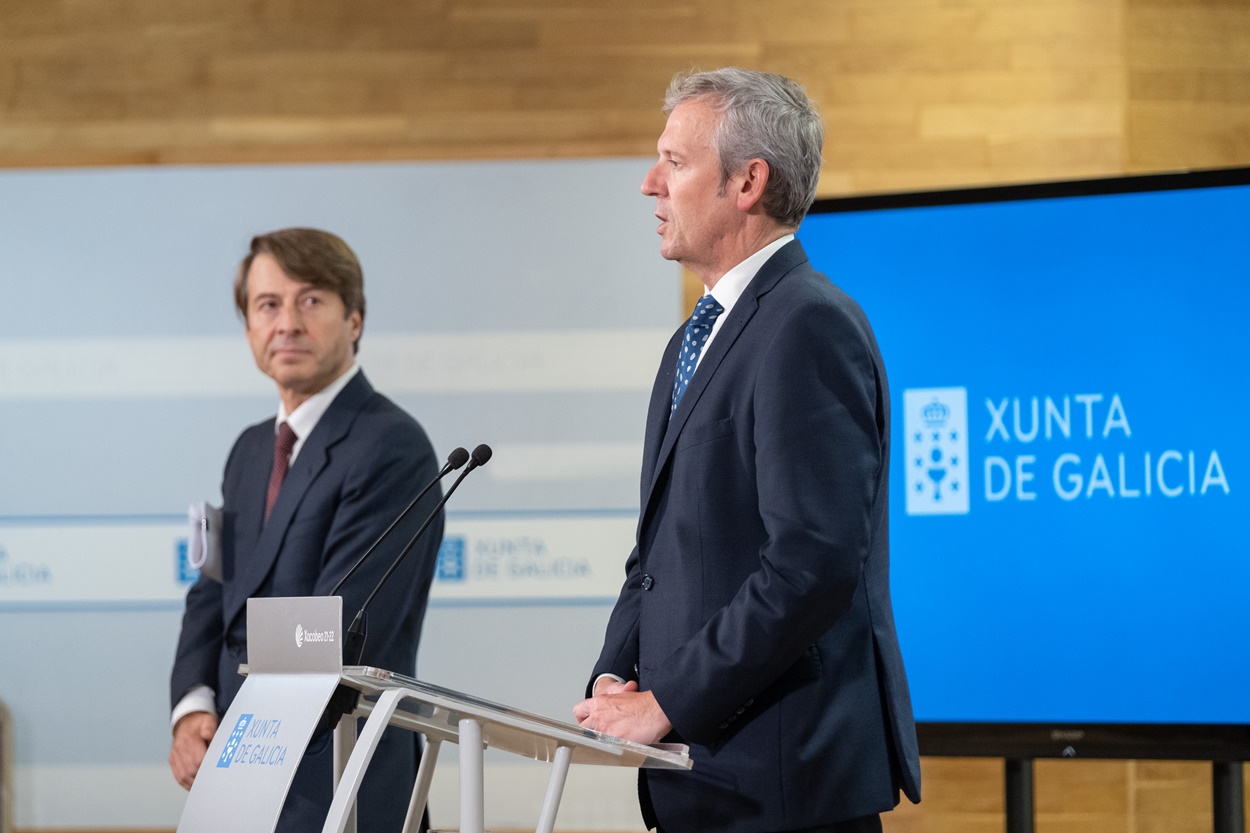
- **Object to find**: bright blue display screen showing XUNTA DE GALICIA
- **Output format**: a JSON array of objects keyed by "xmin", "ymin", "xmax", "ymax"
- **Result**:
[{"xmin": 799, "ymin": 171, "xmax": 1250, "ymax": 723}]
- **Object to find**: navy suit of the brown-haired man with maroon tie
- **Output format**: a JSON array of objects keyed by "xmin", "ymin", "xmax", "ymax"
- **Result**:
[{"xmin": 170, "ymin": 373, "xmax": 443, "ymax": 833}]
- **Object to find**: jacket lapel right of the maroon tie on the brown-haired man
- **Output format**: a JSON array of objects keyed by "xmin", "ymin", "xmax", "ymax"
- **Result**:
[{"xmin": 225, "ymin": 371, "xmax": 374, "ymax": 622}]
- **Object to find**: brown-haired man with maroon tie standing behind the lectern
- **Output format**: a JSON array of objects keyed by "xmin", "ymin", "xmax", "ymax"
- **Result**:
[{"xmin": 169, "ymin": 229, "xmax": 443, "ymax": 833}]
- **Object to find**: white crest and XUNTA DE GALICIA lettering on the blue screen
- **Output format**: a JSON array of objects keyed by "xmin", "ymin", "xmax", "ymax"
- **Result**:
[{"xmin": 903, "ymin": 388, "xmax": 1230, "ymax": 515}]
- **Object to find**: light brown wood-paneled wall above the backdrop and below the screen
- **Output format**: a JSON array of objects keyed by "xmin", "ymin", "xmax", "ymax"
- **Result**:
[{"xmin": 0, "ymin": 0, "xmax": 1250, "ymax": 833}]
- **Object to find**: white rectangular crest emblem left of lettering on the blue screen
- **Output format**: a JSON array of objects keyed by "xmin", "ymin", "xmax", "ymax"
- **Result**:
[{"xmin": 903, "ymin": 388, "xmax": 970, "ymax": 515}]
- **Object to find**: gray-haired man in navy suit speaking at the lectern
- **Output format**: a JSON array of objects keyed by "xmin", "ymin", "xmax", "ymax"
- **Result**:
[{"xmin": 574, "ymin": 69, "xmax": 920, "ymax": 833}]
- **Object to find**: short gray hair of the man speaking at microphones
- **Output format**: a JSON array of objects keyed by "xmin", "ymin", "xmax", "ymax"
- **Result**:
[{"xmin": 664, "ymin": 66, "xmax": 825, "ymax": 229}]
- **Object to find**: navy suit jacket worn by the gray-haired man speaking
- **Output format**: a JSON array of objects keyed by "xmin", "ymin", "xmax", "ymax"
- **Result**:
[{"xmin": 591, "ymin": 241, "xmax": 920, "ymax": 833}]
